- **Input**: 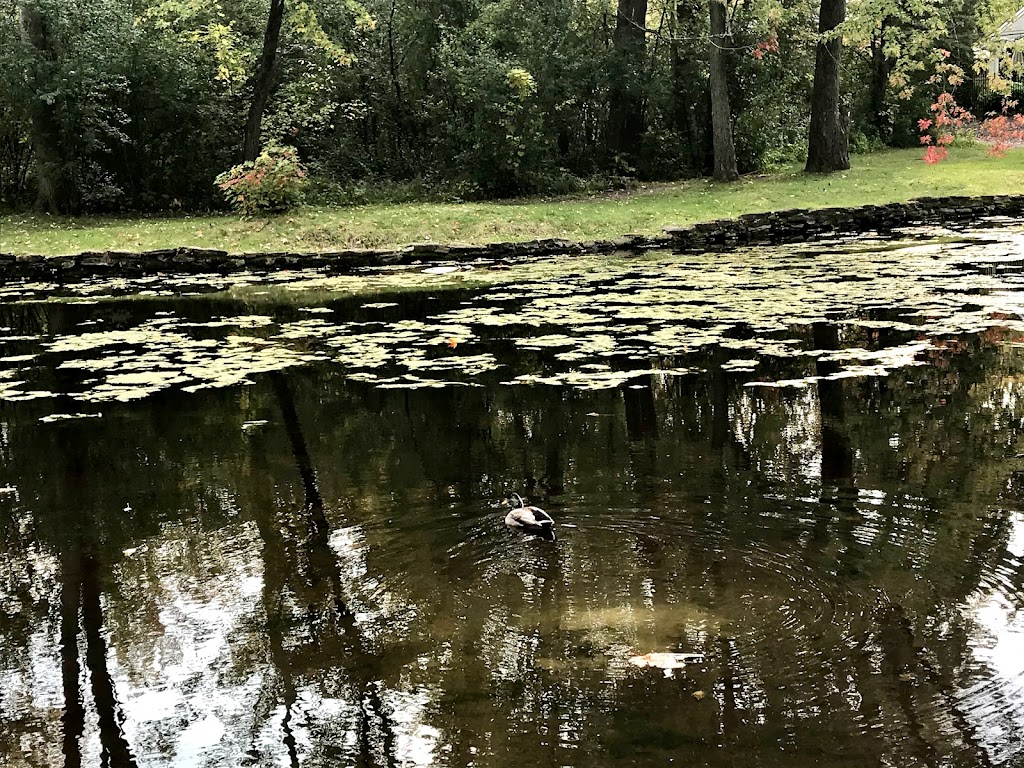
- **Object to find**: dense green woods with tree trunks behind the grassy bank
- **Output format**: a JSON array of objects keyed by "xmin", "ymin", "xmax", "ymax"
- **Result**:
[{"xmin": 0, "ymin": 0, "xmax": 1016, "ymax": 213}]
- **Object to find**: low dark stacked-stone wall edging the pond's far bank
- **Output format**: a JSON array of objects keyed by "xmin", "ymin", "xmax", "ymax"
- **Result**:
[{"xmin": 0, "ymin": 195, "xmax": 1024, "ymax": 284}]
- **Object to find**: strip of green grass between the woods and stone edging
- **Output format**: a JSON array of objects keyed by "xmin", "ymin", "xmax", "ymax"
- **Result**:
[{"xmin": 0, "ymin": 147, "xmax": 1024, "ymax": 255}]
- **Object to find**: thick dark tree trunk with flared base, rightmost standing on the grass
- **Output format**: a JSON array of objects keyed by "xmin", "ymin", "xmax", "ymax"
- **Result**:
[{"xmin": 806, "ymin": 0, "xmax": 850, "ymax": 173}]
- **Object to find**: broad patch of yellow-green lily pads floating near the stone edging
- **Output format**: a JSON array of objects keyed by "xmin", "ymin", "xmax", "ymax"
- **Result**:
[{"xmin": 0, "ymin": 222, "xmax": 1024, "ymax": 409}]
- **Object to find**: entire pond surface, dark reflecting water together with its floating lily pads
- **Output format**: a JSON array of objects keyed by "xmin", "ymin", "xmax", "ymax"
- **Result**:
[{"xmin": 0, "ymin": 222, "xmax": 1024, "ymax": 768}]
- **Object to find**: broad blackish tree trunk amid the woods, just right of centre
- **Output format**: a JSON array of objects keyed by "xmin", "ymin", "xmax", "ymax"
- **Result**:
[{"xmin": 608, "ymin": 0, "xmax": 647, "ymax": 161}]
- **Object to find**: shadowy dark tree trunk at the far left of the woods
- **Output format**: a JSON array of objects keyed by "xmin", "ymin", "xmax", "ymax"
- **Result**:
[{"xmin": 20, "ymin": 2, "xmax": 78, "ymax": 214}]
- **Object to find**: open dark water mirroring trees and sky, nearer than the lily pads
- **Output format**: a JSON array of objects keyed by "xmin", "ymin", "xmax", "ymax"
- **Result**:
[{"xmin": 0, "ymin": 257, "xmax": 1024, "ymax": 766}]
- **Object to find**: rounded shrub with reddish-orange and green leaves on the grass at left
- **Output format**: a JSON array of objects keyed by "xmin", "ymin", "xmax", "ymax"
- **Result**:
[{"xmin": 215, "ymin": 143, "xmax": 306, "ymax": 216}]
